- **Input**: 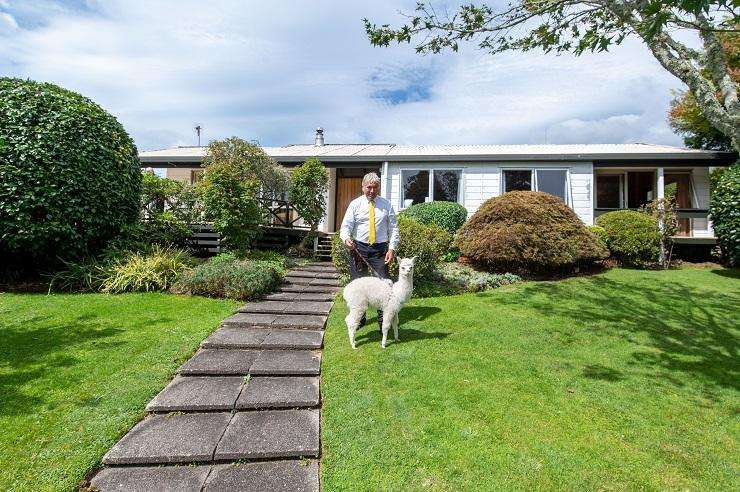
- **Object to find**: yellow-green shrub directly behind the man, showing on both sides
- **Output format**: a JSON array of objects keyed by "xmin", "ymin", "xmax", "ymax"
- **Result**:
[{"xmin": 332, "ymin": 215, "xmax": 452, "ymax": 279}]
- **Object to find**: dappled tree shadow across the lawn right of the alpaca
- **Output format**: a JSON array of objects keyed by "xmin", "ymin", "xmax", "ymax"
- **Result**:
[{"xmin": 482, "ymin": 274, "xmax": 740, "ymax": 397}]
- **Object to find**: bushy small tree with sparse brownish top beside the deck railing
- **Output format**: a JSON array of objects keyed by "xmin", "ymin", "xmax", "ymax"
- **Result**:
[{"xmin": 198, "ymin": 137, "xmax": 288, "ymax": 252}]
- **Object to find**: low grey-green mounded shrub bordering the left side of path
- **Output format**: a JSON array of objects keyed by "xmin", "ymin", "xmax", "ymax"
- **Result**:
[{"xmin": 172, "ymin": 253, "xmax": 284, "ymax": 300}]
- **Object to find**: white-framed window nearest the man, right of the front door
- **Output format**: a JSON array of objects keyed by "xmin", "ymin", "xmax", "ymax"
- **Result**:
[{"xmin": 401, "ymin": 169, "xmax": 462, "ymax": 208}]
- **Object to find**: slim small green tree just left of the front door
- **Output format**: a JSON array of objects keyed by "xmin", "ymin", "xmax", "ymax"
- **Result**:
[{"xmin": 288, "ymin": 157, "xmax": 329, "ymax": 247}]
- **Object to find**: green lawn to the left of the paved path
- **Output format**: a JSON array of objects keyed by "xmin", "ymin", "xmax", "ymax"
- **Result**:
[{"xmin": 0, "ymin": 293, "xmax": 236, "ymax": 491}]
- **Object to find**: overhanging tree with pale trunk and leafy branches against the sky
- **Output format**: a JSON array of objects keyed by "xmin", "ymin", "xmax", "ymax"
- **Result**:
[{"xmin": 364, "ymin": 0, "xmax": 740, "ymax": 150}]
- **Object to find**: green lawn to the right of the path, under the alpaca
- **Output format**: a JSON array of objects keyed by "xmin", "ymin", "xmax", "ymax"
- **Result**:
[{"xmin": 322, "ymin": 269, "xmax": 740, "ymax": 491}]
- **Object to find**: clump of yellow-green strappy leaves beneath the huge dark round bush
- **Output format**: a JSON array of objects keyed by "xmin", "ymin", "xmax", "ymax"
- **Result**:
[{"xmin": 101, "ymin": 246, "xmax": 193, "ymax": 293}]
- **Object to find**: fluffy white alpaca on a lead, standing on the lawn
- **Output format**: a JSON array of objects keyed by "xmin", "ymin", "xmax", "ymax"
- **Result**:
[{"xmin": 342, "ymin": 256, "xmax": 416, "ymax": 348}]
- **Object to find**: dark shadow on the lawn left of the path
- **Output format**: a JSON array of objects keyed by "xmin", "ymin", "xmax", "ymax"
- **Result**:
[{"xmin": 0, "ymin": 315, "xmax": 124, "ymax": 415}]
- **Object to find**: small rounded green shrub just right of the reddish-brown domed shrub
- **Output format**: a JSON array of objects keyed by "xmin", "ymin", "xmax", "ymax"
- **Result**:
[{"xmin": 596, "ymin": 210, "xmax": 660, "ymax": 266}]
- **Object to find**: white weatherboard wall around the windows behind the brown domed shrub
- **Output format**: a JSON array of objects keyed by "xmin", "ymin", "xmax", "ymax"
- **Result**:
[{"xmin": 388, "ymin": 162, "xmax": 593, "ymax": 225}]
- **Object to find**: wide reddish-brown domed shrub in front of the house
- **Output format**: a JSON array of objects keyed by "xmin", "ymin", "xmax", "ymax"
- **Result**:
[{"xmin": 456, "ymin": 191, "xmax": 608, "ymax": 274}]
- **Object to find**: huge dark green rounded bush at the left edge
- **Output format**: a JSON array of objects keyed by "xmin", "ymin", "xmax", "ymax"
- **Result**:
[{"xmin": 0, "ymin": 78, "xmax": 141, "ymax": 266}]
